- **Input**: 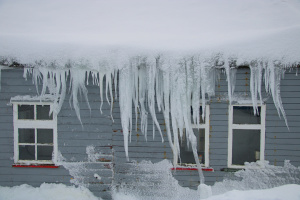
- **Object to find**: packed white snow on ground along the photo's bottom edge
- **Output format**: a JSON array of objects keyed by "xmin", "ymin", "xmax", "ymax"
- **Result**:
[{"xmin": 0, "ymin": 183, "xmax": 300, "ymax": 200}]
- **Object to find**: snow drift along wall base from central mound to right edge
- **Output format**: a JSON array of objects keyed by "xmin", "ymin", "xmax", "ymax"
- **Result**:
[{"xmin": 113, "ymin": 160, "xmax": 300, "ymax": 200}]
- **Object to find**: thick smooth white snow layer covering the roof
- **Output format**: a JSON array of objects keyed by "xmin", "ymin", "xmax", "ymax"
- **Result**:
[{"xmin": 0, "ymin": 0, "xmax": 300, "ymax": 62}]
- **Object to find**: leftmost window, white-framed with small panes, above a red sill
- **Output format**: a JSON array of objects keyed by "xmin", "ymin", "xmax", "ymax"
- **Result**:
[{"xmin": 13, "ymin": 102, "xmax": 57, "ymax": 164}]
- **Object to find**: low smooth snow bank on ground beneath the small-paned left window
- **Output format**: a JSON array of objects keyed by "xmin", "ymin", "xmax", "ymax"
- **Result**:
[{"xmin": 0, "ymin": 183, "xmax": 101, "ymax": 200}]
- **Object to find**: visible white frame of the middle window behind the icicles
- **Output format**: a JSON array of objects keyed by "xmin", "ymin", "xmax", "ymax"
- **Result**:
[{"xmin": 178, "ymin": 105, "xmax": 210, "ymax": 167}]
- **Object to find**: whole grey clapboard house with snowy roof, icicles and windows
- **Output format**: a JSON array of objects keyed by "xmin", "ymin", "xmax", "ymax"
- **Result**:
[{"xmin": 0, "ymin": 0, "xmax": 300, "ymax": 199}]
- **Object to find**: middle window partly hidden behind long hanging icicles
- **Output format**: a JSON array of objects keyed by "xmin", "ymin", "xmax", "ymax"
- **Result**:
[{"xmin": 180, "ymin": 105, "xmax": 209, "ymax": 167}]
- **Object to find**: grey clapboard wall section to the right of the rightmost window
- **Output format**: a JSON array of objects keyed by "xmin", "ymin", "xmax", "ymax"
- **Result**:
[{"xmin": 265, "ymin": 71, "xmax": 300, "ymax": 166}]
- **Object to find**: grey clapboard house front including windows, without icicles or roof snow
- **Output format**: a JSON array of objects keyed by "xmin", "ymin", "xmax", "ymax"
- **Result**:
[{"xmin": 1, "ymin": 59, "xmax": 300, "ymax": 198}]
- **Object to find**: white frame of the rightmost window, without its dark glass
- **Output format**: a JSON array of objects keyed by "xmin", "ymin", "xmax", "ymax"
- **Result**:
[{"xmin": 227, "ymin": 104, "xmax": 266, "ymax": 169}]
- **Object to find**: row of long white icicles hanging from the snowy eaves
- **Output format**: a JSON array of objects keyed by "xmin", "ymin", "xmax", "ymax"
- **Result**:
[{"xmin": 24, "ymin": 55, "xmax": 295, "ymax": 183}]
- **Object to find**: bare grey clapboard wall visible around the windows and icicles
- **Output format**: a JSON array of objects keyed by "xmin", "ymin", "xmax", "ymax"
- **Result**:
[{"xmin": 0, "ymin": 68, "xmax": 300, "ymax": 199}]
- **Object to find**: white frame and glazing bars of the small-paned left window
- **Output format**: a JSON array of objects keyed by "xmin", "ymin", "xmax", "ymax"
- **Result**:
[{"xmin": 12, "ymin": 102, "xmax": 58, "ymax": 165}]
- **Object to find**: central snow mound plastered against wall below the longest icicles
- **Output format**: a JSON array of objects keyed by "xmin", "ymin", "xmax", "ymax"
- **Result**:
[{"xmin": 112, "ymin": 160, "xmax": 199, "ymax": 200}]
